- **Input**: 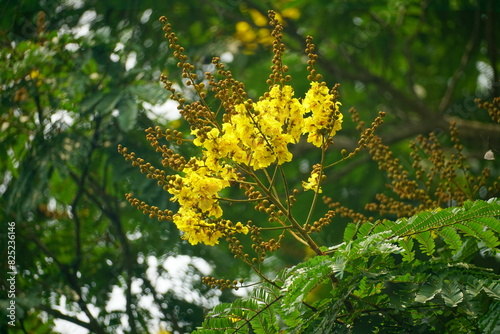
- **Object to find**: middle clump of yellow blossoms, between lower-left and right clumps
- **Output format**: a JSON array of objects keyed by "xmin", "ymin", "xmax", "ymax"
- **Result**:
[{"xmin": 193, "ymin": 85, "xmax": 304, "ymax": 170}]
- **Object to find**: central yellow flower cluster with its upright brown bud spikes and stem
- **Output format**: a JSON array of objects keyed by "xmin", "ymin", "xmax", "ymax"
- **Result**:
[{"xmin": 123, "ymin": 9, "xmax": 343, "ymax": 248}]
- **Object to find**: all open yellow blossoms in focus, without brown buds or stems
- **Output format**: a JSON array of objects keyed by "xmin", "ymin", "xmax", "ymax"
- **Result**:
[{"xmin": 168, "ymin": 82, "xmax": 342, "ymax": 245}]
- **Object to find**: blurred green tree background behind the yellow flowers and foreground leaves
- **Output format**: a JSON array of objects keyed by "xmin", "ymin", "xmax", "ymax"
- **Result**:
[{"xmin": 0, "ymin": 0, "xmax": 500, "ymax": 334}]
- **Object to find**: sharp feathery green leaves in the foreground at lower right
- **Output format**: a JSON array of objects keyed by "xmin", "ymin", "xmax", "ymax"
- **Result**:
[{"xmin": 195, "ymin": 199, "xmax": 500, "ymax": 333}]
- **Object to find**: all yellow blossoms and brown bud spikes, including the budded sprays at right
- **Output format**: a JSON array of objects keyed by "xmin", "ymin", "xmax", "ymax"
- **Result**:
[{"xmin": 119, "ymin": 11, "xmax": 498, "ymax": 288}]
